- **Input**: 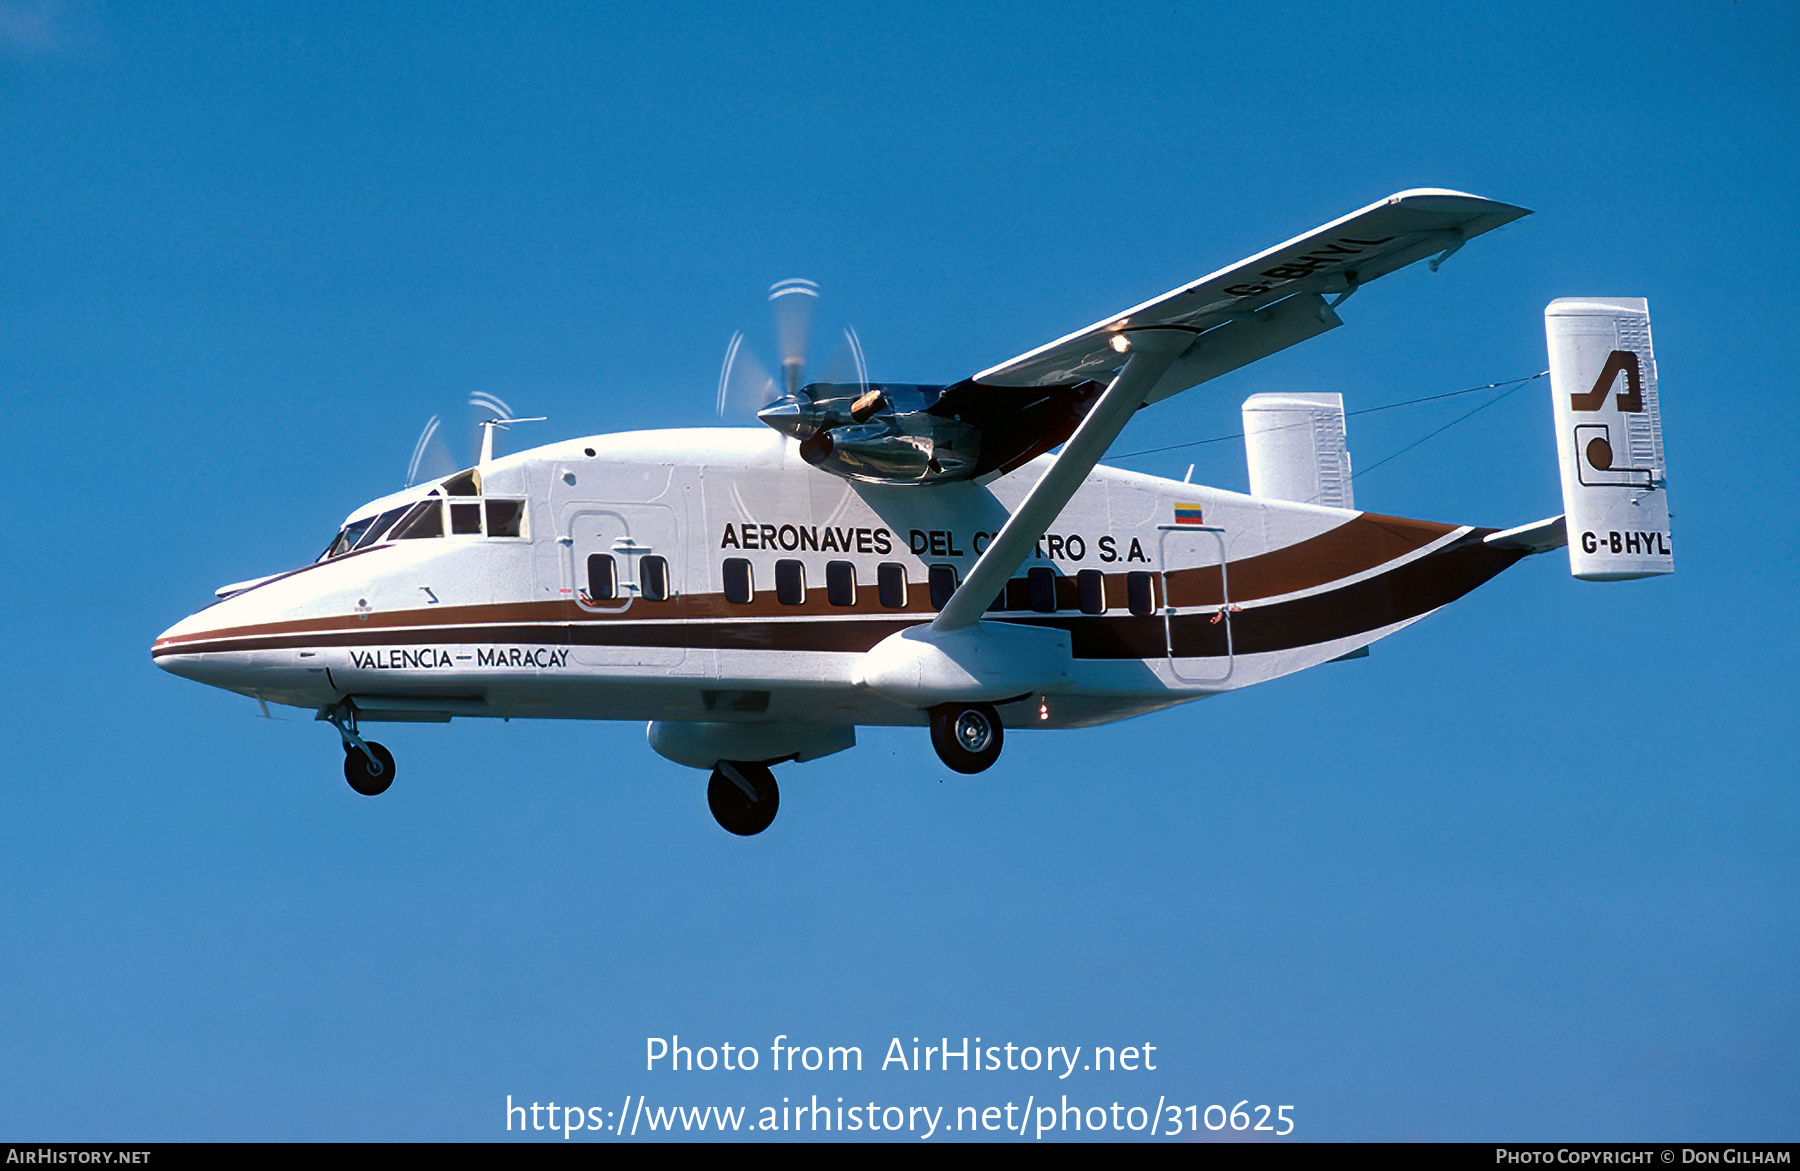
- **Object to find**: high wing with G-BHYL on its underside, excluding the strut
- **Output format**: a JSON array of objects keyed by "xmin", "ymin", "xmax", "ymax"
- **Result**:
[{"xmin": 970, "ymin": 189, "xmax": 1530, "ymax": 403}]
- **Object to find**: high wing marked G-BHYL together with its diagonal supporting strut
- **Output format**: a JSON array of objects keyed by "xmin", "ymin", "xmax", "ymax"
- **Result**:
[{"xmin": 931, "ymin": 189, "xmax": 1530, "ymax": 635}]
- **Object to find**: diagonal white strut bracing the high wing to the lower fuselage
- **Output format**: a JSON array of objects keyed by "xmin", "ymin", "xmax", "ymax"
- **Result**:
[{"xmin": 931, "ymin": 329, "xmax": 1195, "ymax": 633}]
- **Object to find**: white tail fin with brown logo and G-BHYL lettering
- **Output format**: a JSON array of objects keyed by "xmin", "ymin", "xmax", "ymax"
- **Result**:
[{"xmin": 1544, "ymin": 297, "xmax": 1676, "ymax": 581}]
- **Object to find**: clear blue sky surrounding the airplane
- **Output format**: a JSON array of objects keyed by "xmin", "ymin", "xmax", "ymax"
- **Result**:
[{"xmin": 0, "ymin": 0, "xmax": 1800, "ymax": 1140}]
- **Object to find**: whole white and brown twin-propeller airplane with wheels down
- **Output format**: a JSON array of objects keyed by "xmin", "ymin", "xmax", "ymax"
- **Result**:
[{"xmin": 151, "ymin": 189, "xmax": 1674, "ymax": 836}]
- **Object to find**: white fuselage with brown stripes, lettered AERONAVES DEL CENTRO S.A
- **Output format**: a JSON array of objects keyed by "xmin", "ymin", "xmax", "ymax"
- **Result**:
[{"xmin": 153, "ymin": 428, "xmax": 1525, "ymax": 737}]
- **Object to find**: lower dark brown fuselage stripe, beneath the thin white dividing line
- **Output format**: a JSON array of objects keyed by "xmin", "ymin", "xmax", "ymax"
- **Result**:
[{"xmin": 151, "ymin": 529, "xmax": 1526, "ymax": 658}]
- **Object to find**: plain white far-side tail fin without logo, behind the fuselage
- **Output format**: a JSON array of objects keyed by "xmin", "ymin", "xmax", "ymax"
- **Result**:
[{"xmin": 1244, "ymin": 394, "xmax": 1355, "ymax": 509}]
